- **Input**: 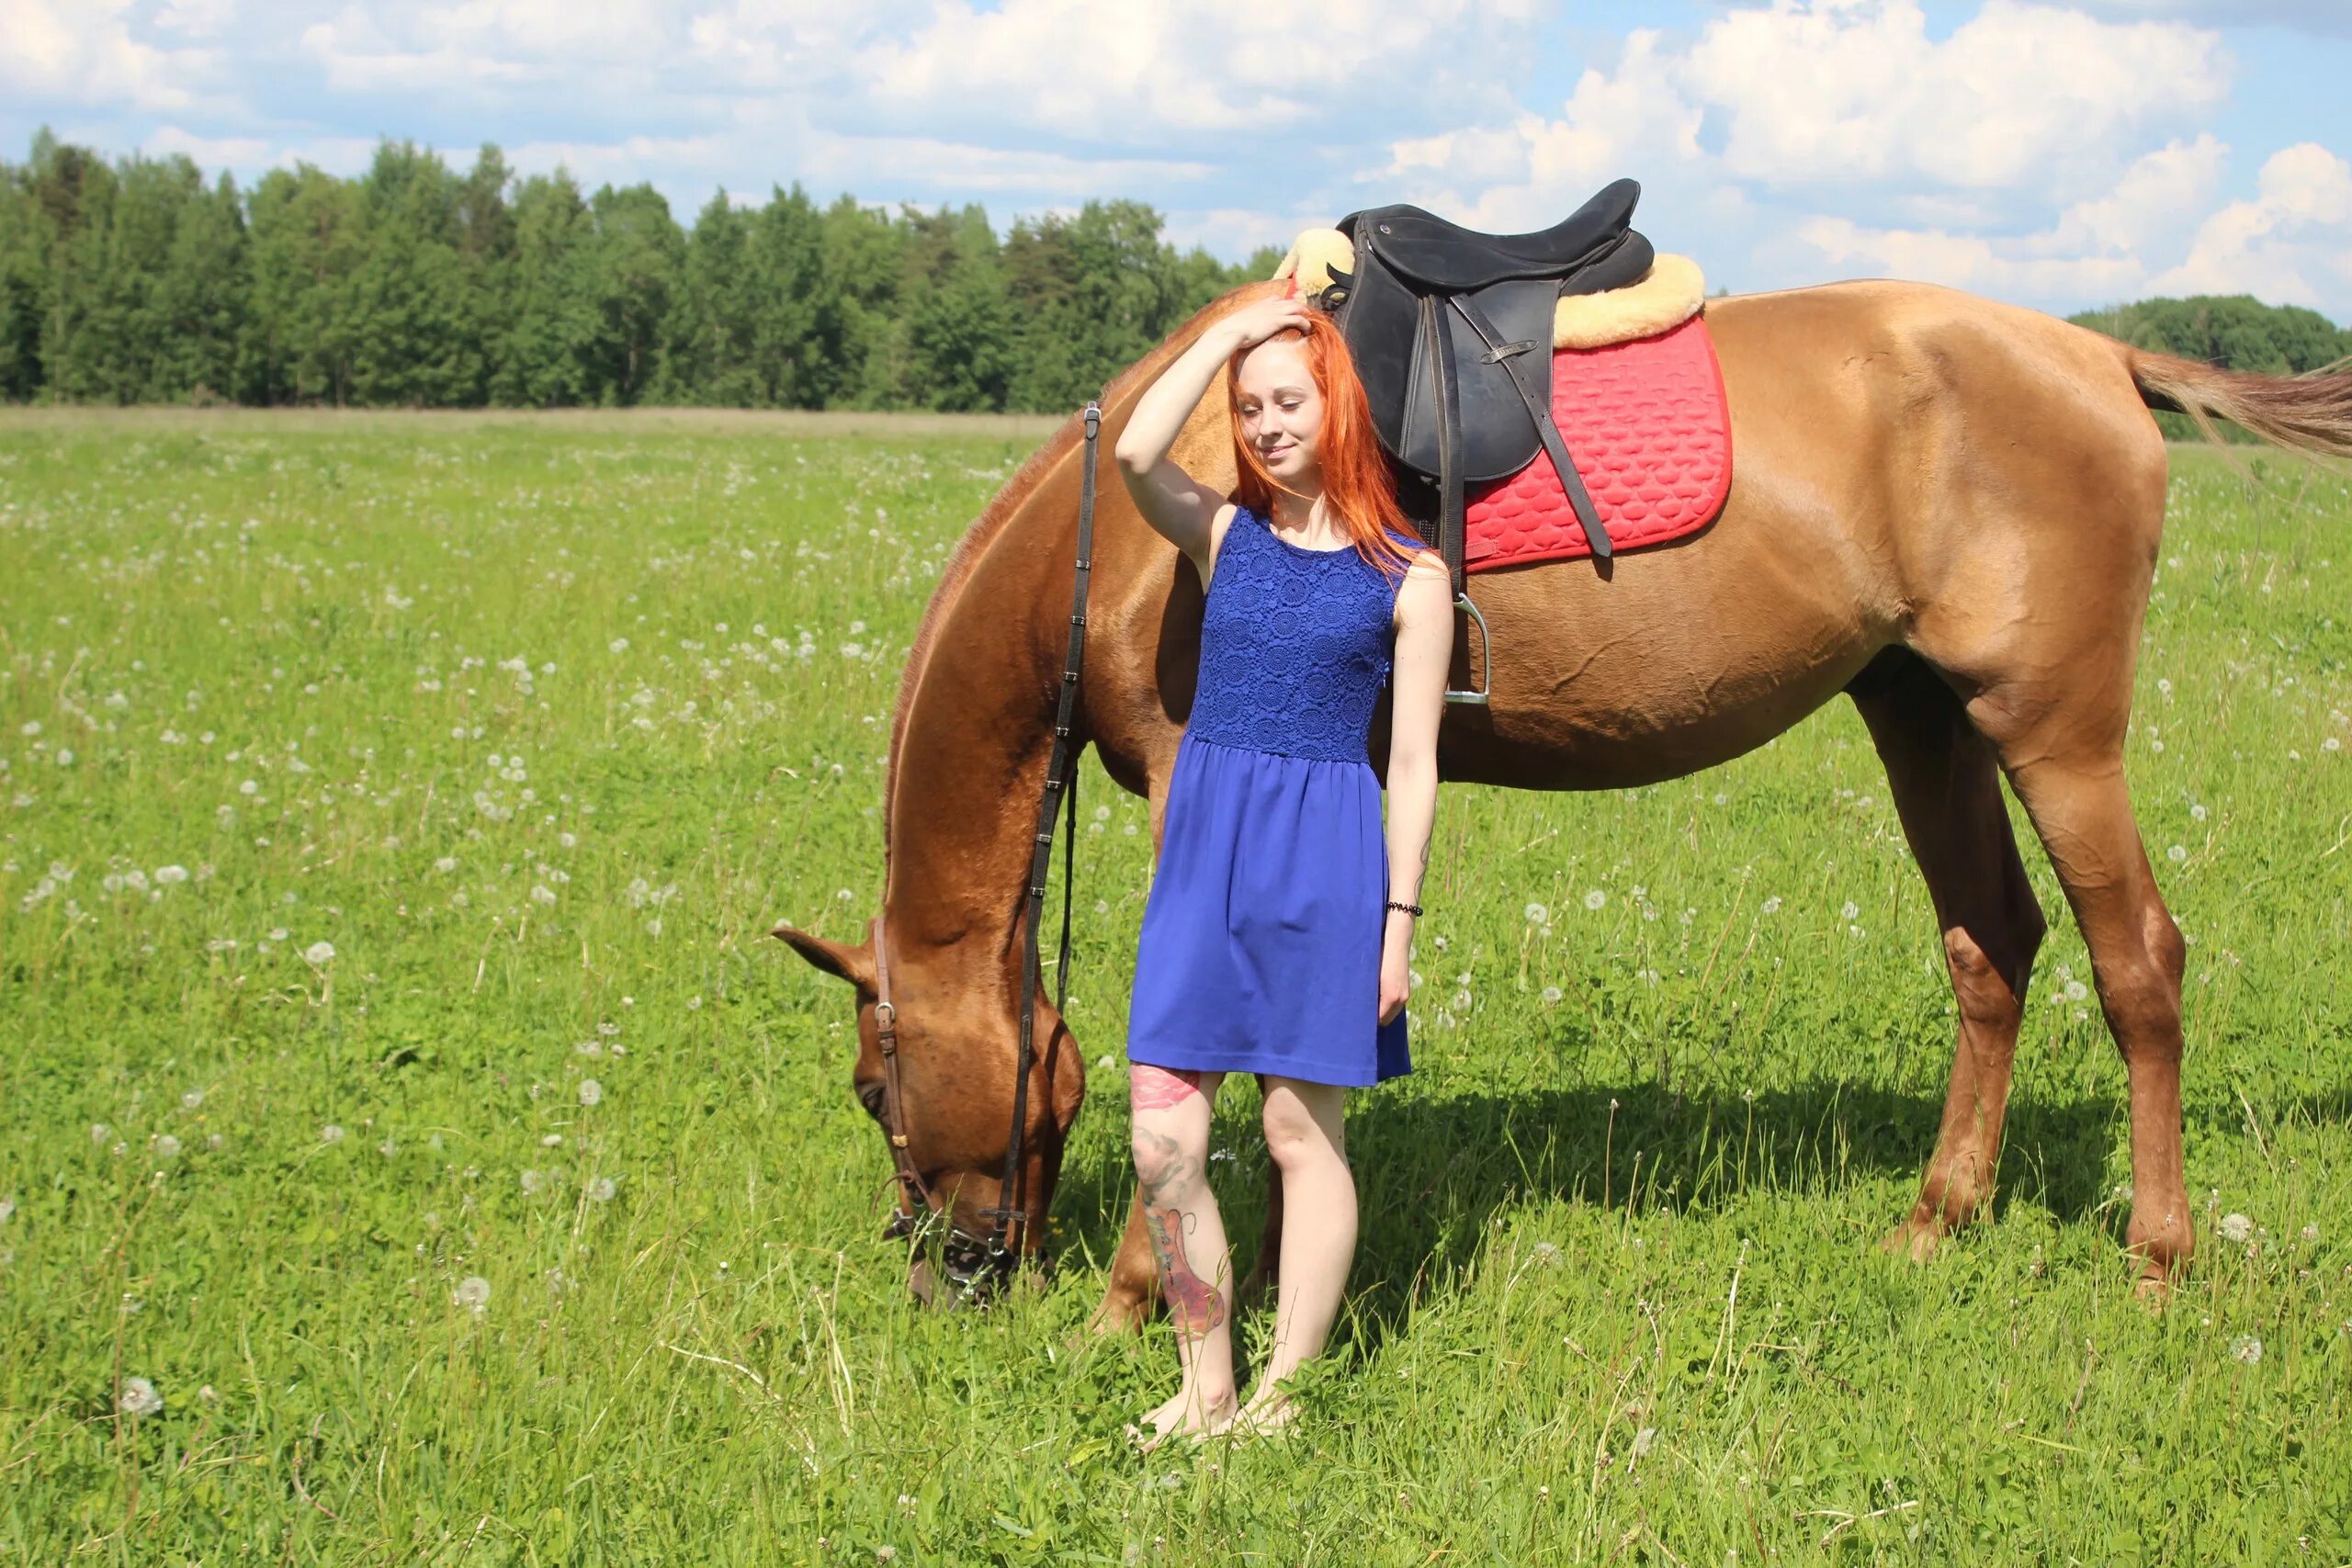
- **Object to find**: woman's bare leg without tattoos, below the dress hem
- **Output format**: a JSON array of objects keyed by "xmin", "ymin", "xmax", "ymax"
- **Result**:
[{"xmin": 1242, "ymin": 1077, "xmax": 1355, "ymax": 1427}]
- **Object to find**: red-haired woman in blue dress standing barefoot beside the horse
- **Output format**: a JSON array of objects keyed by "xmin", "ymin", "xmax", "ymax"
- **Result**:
[{"xmin": 1117, "ymin": 299, "xmax": 1453, "ymax": 1448}]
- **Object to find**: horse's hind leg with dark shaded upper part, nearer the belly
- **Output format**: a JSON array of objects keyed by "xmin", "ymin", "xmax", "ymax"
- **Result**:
[{"xmin": 1847, "ymin": 651, "xmax": 2046, "ymax": 1258}]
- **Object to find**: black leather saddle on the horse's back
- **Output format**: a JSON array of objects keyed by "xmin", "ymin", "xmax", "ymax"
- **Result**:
[{"xmin": 1317, "ymin": 179, "xmax": 1651, "ymax": 600}]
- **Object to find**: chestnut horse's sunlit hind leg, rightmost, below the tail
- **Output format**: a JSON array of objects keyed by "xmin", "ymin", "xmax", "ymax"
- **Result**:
[{"xmin": 2002, "ymin": 738, "xmax": 2194, "ymax": 1291}]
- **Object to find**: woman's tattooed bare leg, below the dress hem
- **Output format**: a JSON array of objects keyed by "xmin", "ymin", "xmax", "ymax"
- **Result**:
[{"xmin": 1129, "ymin": 1063, "xmax": 1235, "ymax": 1448}]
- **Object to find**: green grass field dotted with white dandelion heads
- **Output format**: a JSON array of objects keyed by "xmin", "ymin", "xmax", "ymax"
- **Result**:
[{"xmin": 0, "ymin": 413, "xmax": 2352, "ymax": 1568}]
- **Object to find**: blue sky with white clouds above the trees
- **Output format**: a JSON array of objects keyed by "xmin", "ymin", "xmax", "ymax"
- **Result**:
[{"xmin": 0, "ymin": 0, "xmax": 2352, "ymax": 324}]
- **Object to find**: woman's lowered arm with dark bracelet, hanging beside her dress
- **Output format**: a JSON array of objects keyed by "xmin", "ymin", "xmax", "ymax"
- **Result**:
[{"xmin": 1381, "ymin": 550, "xmax": 1453, "ymax": 1022}]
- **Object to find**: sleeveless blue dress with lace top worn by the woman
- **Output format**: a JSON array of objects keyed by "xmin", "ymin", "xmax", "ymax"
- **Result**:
[{"xmin": 1126, "ymin": 508, "xmax": 1420, "ymax": 1084}]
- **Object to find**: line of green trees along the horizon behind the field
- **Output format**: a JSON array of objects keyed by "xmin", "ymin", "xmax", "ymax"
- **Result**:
[{"xmin": 0, "ymin": 131, "xmax": 2352, "ymax": 419}]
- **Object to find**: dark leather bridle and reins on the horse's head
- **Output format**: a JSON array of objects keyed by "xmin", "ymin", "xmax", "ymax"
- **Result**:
[{"xmin": 865, "ymin": 402, "xmax": 1103, "ymax": 1300}]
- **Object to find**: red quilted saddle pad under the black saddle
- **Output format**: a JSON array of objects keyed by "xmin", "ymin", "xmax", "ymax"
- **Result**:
[{"xmin": 1463, "ymin": 315, "xmax": 1731, "ymax": 571}]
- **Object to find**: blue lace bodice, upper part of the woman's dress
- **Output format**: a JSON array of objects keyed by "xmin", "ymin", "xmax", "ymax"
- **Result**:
[{"xmin": 1185, "ymin": 508, "xmax": 1420, "ymax": 766}]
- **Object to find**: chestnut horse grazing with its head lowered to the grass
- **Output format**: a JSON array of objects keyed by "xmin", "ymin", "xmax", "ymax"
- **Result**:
[{"xmin": 776, "ymin": 272, "xmax": 2352, "ymax": 1328}]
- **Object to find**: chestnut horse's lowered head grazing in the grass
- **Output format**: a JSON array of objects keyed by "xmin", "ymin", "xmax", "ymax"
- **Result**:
[{"xmin": 772, "ymin": 919, "xmax": 1087, "ymax": 1307}]
